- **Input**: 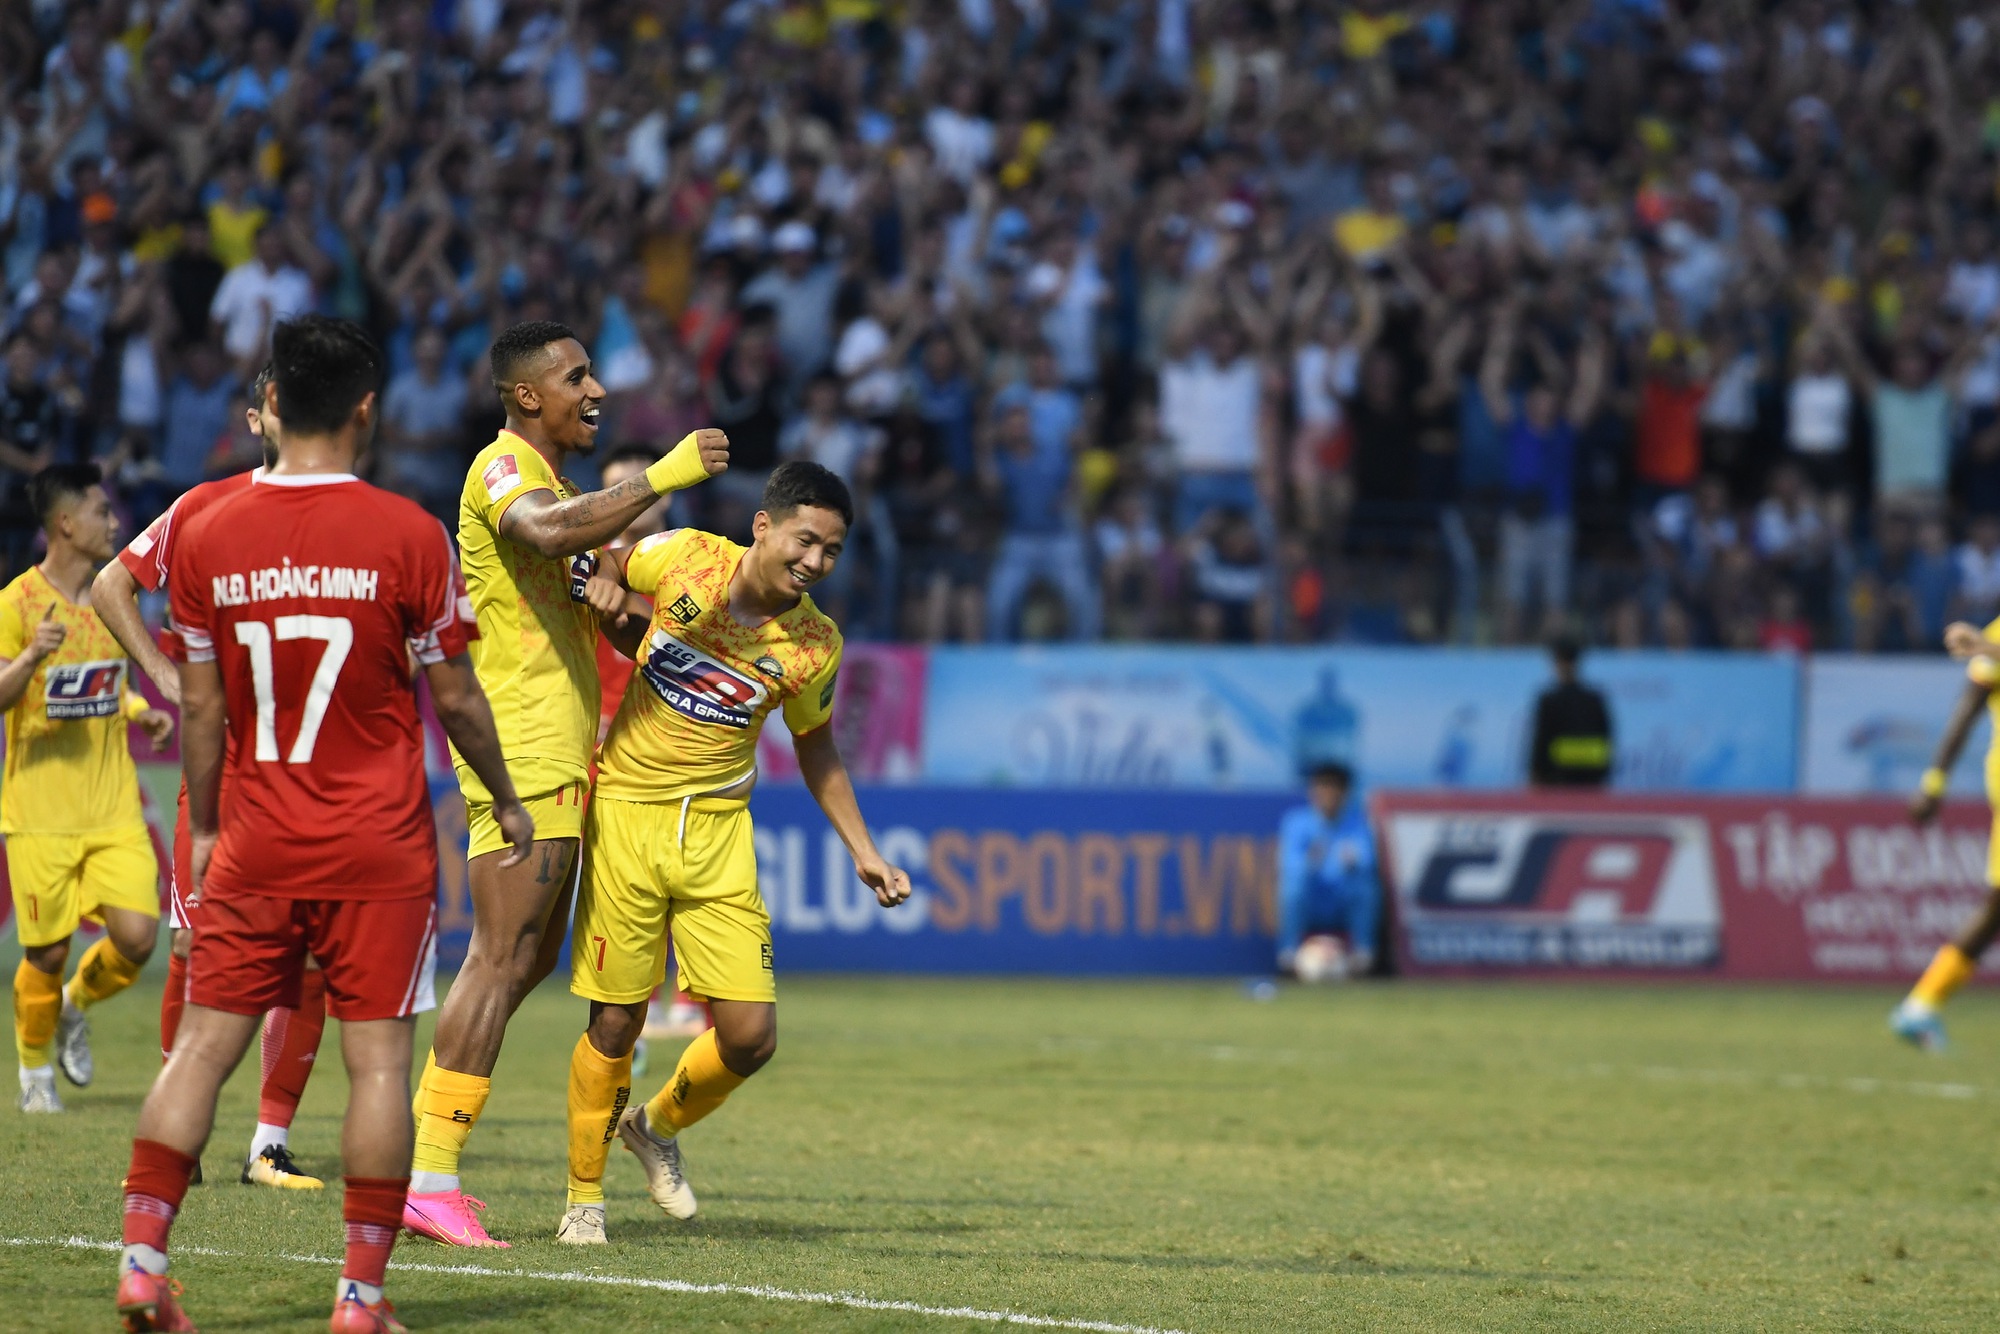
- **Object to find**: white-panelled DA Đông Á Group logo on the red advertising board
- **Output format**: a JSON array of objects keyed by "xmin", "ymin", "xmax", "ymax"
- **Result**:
[{"xmin": 1388, "ymin": 812, "xmax": 1722, "ymax": 968}]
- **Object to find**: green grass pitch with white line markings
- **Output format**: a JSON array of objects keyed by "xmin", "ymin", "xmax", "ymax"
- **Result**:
[{"xmin": 0, "ymin": 978, "xmax": 2000, "ymax": 1334}]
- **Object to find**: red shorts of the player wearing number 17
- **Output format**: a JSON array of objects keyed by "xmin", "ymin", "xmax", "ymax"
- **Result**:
[{"xmin": 188, "ymin": 894, "xmax": 438, "ymax": 1022}]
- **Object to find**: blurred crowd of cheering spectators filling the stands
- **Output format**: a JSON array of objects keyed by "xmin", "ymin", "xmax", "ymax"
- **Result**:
[{"xmin": 0, "ymin": 0, "xmax": 2000, "ymax": 650}]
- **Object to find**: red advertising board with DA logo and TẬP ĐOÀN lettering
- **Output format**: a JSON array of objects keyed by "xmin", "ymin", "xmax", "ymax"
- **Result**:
[{"xmin": 1374, "ymin": 792, "xmax": 1990, "ymax": 982}]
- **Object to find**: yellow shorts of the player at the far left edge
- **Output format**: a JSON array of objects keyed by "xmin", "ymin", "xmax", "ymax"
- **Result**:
[{"xmin": 6, "ymin": 824, "xmax": 160, "ymax": 948}]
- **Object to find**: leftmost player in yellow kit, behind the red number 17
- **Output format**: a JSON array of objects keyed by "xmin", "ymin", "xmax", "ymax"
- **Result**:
[{"xmin": 0, "ymin": 464, "xmax": 174, "ymax": 1112}]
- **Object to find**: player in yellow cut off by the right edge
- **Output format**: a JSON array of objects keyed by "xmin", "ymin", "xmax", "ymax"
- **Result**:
[{"xmin": 1888, "ymin": 620, "xmax": 2000, "ymax": 1052}]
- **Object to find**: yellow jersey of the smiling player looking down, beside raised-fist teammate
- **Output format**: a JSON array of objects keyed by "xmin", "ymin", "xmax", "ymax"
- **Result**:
[{"xmin": 598, "ymin": 528, "xmax": 840, "ymax": 802}]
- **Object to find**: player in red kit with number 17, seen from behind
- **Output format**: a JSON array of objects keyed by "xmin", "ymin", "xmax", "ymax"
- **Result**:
[{"xmin": 118, "ymin": 316, "xmax": 534, "ymax": 1334}]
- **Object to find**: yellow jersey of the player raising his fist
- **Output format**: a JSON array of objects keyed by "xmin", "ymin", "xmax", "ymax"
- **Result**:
[{"xmin": 452, "ymin": 430, "xmax": 598, "ymax": 796}]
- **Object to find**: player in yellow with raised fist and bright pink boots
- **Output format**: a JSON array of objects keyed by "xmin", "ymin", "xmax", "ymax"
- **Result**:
[{"xmin": 404, "ymin": 322, "xmax": 728, "ymax": 1246}]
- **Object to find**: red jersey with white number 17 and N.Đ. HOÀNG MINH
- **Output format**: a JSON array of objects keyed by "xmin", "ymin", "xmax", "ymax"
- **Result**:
[{"xmin": 168, "ymin": 476, "xmax": 476, "ymax": 900}]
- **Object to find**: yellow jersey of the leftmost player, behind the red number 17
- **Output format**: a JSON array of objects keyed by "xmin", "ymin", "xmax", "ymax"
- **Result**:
[{"xmin": 0, "ymin": 566, "xmax": 146, "ymax": 834}]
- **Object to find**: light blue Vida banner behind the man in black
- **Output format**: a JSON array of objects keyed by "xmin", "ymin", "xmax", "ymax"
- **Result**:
[{"xmin": 922, "ymin": 648, "xmax": 1798, "ymax": 792}]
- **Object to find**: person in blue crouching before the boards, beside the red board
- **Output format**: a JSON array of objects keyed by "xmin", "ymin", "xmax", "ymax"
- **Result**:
[{"xmin": 1278, "ymin": 762, "xmax": 1382, "ymax": 974}]
